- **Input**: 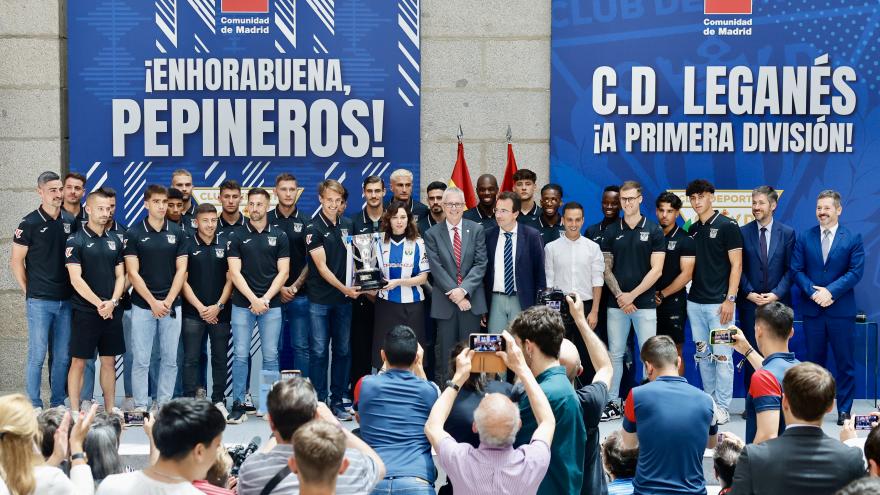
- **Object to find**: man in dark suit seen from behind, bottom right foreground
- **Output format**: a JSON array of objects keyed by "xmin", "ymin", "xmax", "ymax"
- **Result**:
[{"xmin": 730, "ymin": 363, "xmax": 865, "ymax": 495}]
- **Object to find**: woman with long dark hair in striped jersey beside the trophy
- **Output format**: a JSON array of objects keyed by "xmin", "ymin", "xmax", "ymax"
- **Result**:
[{"xmin": 368, "ymin": 201, "xmax": 430, "ymax": 369}]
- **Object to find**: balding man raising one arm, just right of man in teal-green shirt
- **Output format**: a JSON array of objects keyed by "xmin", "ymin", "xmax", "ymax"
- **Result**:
[{"xmin": 559, "ymin": 295, "xmax": 614, "ymax": 494}]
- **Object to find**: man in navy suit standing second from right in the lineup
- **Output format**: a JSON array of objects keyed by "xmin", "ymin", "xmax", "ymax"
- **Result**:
[{"xmin": 736, "ymin": 186, "xmax": 795, "ymax": 400}]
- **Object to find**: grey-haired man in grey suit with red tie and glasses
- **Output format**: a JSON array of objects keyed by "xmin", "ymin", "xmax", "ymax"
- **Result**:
[{"xmin": 425, "ymin": 187, "xmax": 487, "ymax": 386}]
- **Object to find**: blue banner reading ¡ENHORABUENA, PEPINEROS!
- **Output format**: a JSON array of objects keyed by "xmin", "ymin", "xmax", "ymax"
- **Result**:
[{"xmin": 68, "ymin": 0, "xmax": 421, "ymax": 219}]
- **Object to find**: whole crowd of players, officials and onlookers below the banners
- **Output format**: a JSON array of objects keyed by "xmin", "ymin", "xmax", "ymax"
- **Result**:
[{"xmin": 0, "ymin": 169, "xmax": 880, "ymax": 495}]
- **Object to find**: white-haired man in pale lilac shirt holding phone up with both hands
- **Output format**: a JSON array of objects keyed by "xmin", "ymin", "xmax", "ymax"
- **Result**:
[{"xmin": 425, "ymin": 332, "xmax": 556, "ymax": 495}]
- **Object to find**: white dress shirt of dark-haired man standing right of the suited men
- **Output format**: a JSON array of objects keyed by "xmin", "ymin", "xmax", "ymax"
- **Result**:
[{"xmin": 544, "ymin": 234, "xmax": 605, "ymax": 301}]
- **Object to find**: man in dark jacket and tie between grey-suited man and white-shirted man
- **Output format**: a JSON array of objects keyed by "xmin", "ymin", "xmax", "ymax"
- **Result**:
[{"xmin": 483, "ymin": 191, "xmax": 547, "ymax": 333}]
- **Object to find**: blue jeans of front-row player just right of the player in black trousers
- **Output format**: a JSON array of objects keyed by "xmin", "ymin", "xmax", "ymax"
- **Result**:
[{"xmin": 232, "ymin": 306, "xmax": 281, "ymax": 411}]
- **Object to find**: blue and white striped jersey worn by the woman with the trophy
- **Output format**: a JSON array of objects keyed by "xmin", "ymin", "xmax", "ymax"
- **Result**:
[{"xmin": 379, "ymin": 237, "xmax": 431, "ymax": 303}]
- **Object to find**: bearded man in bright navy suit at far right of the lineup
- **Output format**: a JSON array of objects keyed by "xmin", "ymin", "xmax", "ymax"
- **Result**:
[{"xmin": 791, "ymin": 190, "xmax": 865, "ymax": 425}]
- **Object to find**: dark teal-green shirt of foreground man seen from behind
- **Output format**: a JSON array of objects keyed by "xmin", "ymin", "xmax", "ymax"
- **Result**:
[{"xmin": 515, "ymin": 366, "xmax": 587, "ymax": 495}]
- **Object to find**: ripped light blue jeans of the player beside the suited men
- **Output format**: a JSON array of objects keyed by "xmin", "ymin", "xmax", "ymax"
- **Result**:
[{"xmin": 688, "ymin": 301, "xmax": 733, "ymax": 411}]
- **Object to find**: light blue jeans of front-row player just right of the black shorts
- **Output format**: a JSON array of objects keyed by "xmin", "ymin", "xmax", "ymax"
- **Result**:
[{"xmin": 131, "ymin": 306, "xmax": 182, "ymax": 408}]
